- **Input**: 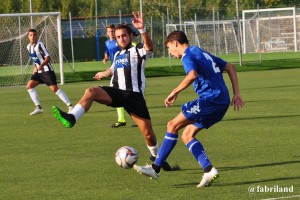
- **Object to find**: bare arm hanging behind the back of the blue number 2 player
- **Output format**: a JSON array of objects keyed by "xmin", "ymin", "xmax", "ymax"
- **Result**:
[{"xmin": 225, "ymin": 63, "xmax": 245, "ymax": 111}]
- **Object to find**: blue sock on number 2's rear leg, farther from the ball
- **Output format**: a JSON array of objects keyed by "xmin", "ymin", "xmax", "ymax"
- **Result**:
[{"xmin": 186, "ymin": 138, "xmax": 211, "ymax": 169}]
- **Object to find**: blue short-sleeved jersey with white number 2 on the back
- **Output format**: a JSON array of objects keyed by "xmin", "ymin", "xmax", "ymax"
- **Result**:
[{"xmin": 181, "ymin": 46, "xmax": 230, "ymax": 104}]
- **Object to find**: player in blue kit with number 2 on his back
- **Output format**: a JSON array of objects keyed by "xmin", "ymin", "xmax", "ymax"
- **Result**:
[{"xmin": 134, "ymin": 31, "xmax": 244, "ymax": 187}]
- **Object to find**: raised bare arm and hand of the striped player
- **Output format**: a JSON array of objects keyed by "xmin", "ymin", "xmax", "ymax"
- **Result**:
[{"xmin": 131, "ymin": 11, "xmax": 153, "ymax": 51}]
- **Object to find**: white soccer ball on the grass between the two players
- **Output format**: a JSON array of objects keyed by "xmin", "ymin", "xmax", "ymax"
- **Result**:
[{"xmin": 115, "ymin": 146, "xmax": 139, "ymax": 169}]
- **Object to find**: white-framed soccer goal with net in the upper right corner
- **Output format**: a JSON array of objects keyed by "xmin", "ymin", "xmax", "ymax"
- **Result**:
[{"xmin": 243, "ymin": 7, "xmax": 300, "ymax": 53}]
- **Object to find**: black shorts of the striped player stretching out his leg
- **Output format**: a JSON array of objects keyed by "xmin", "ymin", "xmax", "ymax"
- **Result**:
[{"xmin": 100, "ymin": 86, "xmax": 150, "ymax": 120}]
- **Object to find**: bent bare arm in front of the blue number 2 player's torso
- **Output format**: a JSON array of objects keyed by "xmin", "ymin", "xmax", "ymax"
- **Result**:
[{"xmin": 165, "ymin": 70, "xmax": 198, "ymax": 107}]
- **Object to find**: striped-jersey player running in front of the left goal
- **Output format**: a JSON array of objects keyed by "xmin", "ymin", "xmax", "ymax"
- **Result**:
[{"xmin": 26, "ymin": 29, "xmax": 73, "ymax": 115}]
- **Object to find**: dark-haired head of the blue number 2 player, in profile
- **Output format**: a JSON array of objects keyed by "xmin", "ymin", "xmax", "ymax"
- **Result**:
[{"xmin": 165, "ymin": 31, "xmax": 189, "ymax": 58}]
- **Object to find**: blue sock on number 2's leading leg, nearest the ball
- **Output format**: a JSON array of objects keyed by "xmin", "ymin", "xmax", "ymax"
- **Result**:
[{"xmin": 154, "ymin": 132, "xmax": 178, "ymax": 167}]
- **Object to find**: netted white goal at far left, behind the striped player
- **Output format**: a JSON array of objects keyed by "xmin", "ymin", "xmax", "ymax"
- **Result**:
[{"xmin": 0, "ymin": 12, "xmax": 64, "ymax": 87}]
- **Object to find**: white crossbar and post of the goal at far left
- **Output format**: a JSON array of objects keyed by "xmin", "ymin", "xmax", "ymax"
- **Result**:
[{"xmin": 0, "ymin": 12, "xmax": 65, "ymax": 85}]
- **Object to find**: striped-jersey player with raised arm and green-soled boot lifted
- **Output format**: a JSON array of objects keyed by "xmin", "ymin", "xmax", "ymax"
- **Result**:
[{"xmin": 52, "ymin": 12, "xmax": 171, "ymax": 170}]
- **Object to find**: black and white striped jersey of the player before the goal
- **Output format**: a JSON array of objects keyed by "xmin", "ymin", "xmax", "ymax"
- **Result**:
[{"xmin": 27, "ymin": 41, "xmax": 54, "ymax": 72}]
